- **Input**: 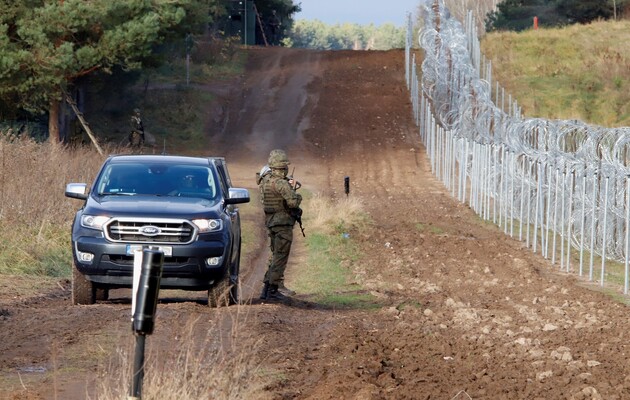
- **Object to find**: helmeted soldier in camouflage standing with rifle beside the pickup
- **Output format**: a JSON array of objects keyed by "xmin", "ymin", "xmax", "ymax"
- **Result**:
[{"xmin": 257, "ymin": 150, "xmax": 302, "ymax": 300}]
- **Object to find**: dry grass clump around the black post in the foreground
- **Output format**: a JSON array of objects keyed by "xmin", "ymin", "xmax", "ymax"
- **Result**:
[{"xmin": 96, "ymin": 312, "xmax": 270, "ymax": 400}]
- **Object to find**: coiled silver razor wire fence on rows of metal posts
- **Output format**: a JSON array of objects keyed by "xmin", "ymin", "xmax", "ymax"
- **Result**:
[{"xmin": 405, "ymin": 0, "xmax": 630, "ymax": 294}]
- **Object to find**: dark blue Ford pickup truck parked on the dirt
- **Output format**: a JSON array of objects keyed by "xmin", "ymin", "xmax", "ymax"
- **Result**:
[{"xmin": 65, "ymin": 155, "xmax": 250, "ymax": 307}]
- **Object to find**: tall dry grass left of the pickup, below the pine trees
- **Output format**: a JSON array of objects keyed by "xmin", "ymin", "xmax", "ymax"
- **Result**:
[{"xmin": 0, "ymin": 135, "xmax": 133, "ymax": 276}]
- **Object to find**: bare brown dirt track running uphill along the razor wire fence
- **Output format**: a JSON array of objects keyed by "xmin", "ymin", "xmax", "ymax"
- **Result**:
[{"xmin": 0, "ymin": 49, "xmax": 630, "ymax": 400}]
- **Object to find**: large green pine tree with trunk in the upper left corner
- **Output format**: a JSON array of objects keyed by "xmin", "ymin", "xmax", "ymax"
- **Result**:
[{"xmin": 0, "ymin": 0, "xmax": 215, "ymax": 141}]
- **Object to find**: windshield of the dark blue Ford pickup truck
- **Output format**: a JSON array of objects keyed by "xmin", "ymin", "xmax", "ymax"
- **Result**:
[{"xmin": 94, "ymin": 163, "xmax": 217, "ymax": 199}]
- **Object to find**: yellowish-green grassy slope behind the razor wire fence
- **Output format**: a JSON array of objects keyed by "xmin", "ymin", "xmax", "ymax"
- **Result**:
[{"xmin": 481, "ymin": 21, "xmax": 630, "ymax": 127}]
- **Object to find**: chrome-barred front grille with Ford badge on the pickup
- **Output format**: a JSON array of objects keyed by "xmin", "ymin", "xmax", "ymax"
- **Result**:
[{"xmin": 105, "ymin": 218, "xmax": 197, "ymax": 244}]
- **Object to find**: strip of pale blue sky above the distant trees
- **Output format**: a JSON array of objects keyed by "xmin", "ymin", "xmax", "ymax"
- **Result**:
[{"xmin": 294, "ymin": 0, "xmax": 422, "ymax": 26}]
